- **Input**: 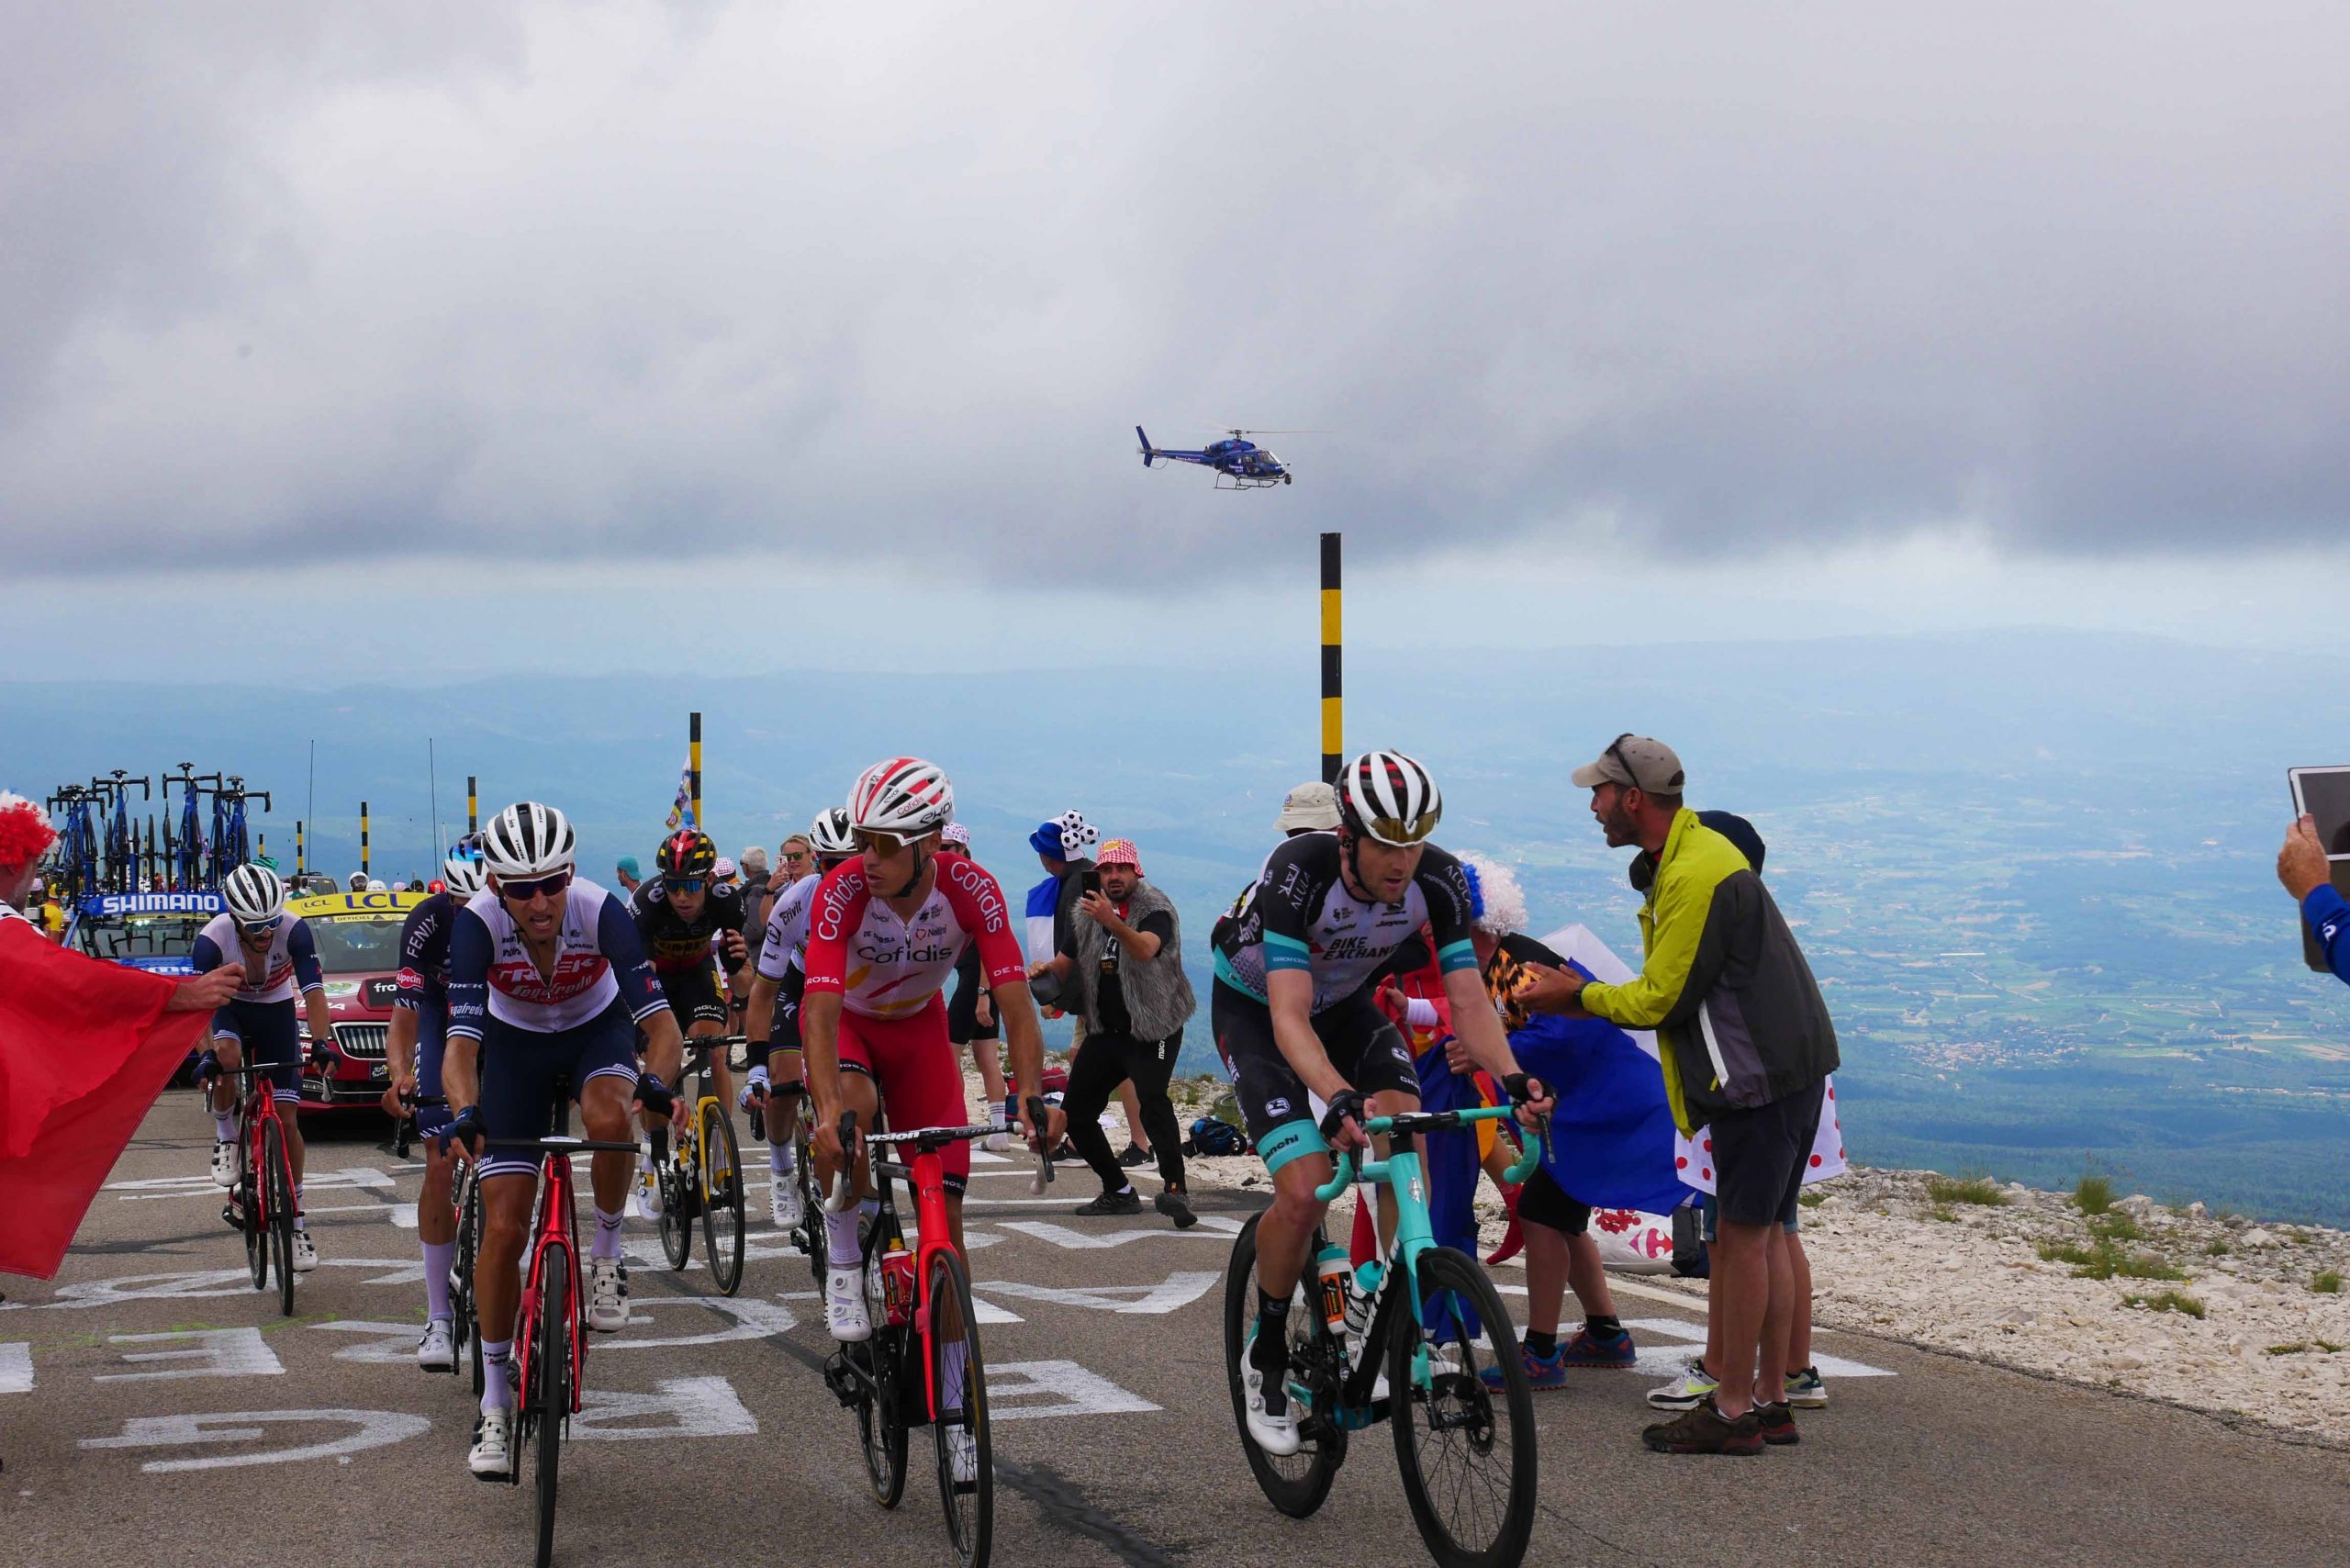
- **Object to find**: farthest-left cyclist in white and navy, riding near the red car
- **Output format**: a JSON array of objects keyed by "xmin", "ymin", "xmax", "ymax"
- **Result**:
[{"xmin": 188, "ymin": 865, "xmax": 334, "ymax": 1274}]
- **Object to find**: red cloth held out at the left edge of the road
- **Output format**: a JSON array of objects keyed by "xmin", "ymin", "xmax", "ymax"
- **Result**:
[{"xmin": 0, "ymin": 919, "xmax": 211, "ymax": 1279}]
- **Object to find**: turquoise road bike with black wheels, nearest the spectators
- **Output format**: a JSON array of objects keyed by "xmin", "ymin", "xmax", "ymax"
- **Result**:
[{"xmin": 1225, "ymin": 1107, "xmax": 1549, "ymax": 1568}]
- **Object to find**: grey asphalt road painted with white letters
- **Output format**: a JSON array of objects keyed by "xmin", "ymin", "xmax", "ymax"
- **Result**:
[{"xmin": 0, "ymin": 1093, "xmax": 2350, "ymax": 1568}]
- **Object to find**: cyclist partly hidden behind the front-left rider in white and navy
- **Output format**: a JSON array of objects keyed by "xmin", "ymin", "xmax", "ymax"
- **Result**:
[{"xmin": 383, "ymin": 837, "xmax": 488, "ymax": 1372}]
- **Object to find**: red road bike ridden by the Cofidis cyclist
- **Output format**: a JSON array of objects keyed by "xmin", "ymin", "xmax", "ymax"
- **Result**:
[{"xmin": 811, "ymin": 1100, "xmax": 1053, "ymax": 1568}]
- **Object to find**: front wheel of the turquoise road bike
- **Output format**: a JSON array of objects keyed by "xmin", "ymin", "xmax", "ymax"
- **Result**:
[{"xmin": 1386, "ymin": 1246, "xmax": 1535, "ymax": 1568}]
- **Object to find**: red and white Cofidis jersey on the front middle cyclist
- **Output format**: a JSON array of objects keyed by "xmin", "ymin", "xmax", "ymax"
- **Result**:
[{"xmin": 804, "ymin": 854, "xmax": 1027, "ymax": 1039}]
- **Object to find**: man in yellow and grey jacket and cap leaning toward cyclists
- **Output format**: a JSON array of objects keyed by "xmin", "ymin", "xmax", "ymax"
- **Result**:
[{"xmin": 1518, "ymin": 734, "xmax": 1838, "ymax": 1453}]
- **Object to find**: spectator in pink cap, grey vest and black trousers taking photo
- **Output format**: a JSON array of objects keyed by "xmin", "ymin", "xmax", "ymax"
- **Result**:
[{"xmin": 1058, "ymin": 839, "xmax": 1199, "ymax": 1229}]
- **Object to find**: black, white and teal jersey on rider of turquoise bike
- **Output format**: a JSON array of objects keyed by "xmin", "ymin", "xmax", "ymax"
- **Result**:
[{"xmin": 1215, "ymin": 832, "xmax": 1476, "ymax": 1014}]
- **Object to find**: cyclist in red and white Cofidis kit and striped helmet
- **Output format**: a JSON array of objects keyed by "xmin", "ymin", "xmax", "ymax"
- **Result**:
[{"xmin": 799, "ymin": 757, "xmax": 1062, "ymax": 1340}]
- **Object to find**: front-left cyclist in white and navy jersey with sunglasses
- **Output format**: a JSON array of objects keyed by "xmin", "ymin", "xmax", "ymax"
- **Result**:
[{"xmin": 442, "ymin": 801, "xmax": 684, "ymax": 1481}]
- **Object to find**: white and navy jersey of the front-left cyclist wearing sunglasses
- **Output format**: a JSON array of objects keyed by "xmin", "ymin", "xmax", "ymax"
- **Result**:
[{"xmin": 449, "ymin": 877, "xmax": 667, "ymax": 1039}]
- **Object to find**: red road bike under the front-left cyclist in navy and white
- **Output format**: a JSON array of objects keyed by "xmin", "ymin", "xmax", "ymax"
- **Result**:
[{"xmin": 481, "ymin": 1081, "xmax": 639, "ymax": 1568}]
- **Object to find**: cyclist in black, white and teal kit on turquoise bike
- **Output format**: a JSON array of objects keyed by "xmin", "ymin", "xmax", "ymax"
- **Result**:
[{"xmin": 1213, "ymin": 752, "xmax": 1551, "ymax": 1455}]
